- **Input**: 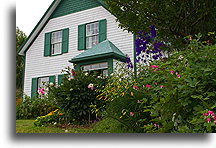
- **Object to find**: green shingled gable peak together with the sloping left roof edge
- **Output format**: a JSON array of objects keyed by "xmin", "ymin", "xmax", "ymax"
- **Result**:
[{"xmin": 18, "ymin": 0, "xmax": 106, "ymax": 56}]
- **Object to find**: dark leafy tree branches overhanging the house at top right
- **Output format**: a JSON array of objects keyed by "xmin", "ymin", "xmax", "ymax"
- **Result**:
[{"xmin": 105, "ymin": 0, "xmax": 216, "ymax": 48}]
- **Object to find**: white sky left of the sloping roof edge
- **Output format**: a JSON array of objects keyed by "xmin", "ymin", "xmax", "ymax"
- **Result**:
[{"xmin": 16, "ymin": 0, "xmax": 53, "ymax": 35}]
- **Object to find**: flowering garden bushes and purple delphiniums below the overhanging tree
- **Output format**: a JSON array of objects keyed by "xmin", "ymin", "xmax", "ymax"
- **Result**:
[{"xmin": 16, "ymin": 26, "xmax": 216, "ymax": 133}]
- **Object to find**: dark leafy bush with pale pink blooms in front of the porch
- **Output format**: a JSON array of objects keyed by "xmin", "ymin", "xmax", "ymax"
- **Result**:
[{"xmin": 49, "ymin": 68, "xmax": 106, "ymax": 124}]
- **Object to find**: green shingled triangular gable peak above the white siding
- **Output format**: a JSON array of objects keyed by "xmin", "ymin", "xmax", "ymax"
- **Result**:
[{"xmin": 50, "ymin": 0, "xmax": 101, "ymax": 18}]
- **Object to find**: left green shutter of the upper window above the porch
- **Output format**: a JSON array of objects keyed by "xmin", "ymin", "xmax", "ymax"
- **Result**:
[{"xmin": 78, "ymin": 24, "xmax": 86, "ymax": 50}]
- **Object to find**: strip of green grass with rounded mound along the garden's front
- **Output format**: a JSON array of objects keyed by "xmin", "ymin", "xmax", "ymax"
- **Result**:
[{"xmin": 16, "ymin": 118, "xmax": 131, "ymax": 133}]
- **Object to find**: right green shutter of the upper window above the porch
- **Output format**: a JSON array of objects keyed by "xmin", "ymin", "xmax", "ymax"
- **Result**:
[{"xmin": 99, "ymin": 19, "xmax": 107, "ymax": 43}]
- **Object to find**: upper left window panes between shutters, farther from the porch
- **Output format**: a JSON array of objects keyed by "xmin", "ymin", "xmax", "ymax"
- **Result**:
[{"xmin": 51, "ymin": 31, "xmax": 62, "ymax": 55}]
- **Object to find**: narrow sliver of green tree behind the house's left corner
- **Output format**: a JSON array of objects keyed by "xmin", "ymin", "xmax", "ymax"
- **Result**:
[{"xmin": 16, "ymin": 27, "xmax": 27, "ymax": 89}]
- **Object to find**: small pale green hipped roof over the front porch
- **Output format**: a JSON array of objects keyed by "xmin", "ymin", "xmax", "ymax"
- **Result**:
[{"xmin": 69, "ymin": 40, "xmax": 126, "ymax": 63}]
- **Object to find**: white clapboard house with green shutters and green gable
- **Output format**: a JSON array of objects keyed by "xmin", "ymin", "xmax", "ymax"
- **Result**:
[{"xmin": 19, "ymin": 0, "xmax": 135, "ymax": 97}]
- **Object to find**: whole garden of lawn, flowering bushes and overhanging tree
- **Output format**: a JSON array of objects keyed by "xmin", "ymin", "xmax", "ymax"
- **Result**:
[{"xmin": 16, "ymin": 0, "xmax": 216, "ymax": 133}]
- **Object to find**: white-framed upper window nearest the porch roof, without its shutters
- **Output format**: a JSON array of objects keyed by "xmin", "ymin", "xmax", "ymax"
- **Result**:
[{"xmin": 86, "ymin": 22, "xmax": 99, "ymax": 49}]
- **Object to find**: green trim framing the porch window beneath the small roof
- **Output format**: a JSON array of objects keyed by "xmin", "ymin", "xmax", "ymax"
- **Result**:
[{"xmin": 76, "ymin": 58, "xmax": 113, "ymax": 76}]
